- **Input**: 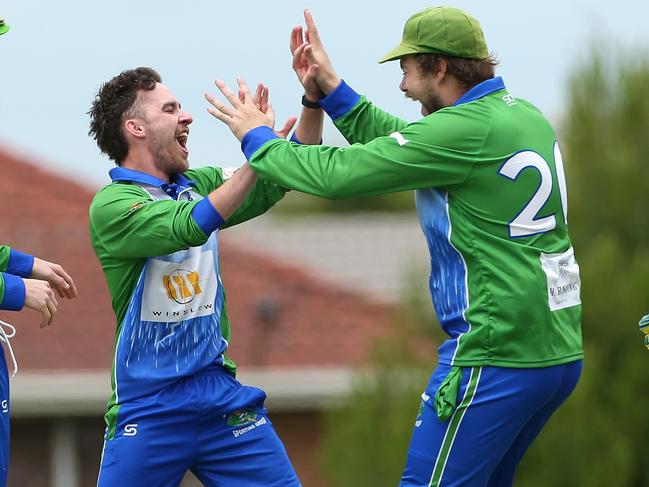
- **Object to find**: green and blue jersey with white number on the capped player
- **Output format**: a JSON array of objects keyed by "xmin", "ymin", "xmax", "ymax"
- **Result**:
[{"xmin": 242, "ymin": 78, "xmax": 583, "ymax": 367}]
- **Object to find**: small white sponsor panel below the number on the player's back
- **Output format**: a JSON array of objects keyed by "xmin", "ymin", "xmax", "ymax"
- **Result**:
[{"xmin": 541, "ymin": 247, "xmax": 581, "ymax": 311}]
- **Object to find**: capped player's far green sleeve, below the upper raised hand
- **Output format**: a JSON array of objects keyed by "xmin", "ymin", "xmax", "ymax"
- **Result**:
[{"xmin": 334, "ymin": 96, "xmax": 408, "ymax": 144}]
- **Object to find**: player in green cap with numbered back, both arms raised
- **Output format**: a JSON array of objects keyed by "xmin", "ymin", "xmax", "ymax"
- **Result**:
[{"xmin": 207, "ymin": 7, "xmax": 583, "ymax": 487}]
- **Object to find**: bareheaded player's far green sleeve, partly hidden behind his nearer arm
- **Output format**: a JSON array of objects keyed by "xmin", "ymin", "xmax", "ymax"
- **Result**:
[{"xmin": 185, "ymin": 167, "xmax": 286, "ymax": 228}]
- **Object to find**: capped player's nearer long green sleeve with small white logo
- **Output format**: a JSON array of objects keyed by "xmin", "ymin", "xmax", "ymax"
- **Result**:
[{"xmin": 249, "ymin": 110, "xmax": 488, "ymax": 198}]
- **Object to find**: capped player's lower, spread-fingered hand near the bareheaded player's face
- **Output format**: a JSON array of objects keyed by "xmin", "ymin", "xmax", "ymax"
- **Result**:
[{"xmin": 205, "ymin": 78, "xmax": 296, "ymax": 140}]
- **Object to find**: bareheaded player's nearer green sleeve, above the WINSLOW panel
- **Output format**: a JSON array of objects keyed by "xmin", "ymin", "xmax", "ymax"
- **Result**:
[{"xmin": 90, "ymin": 183, "xmax": 207, "ymax": 259}]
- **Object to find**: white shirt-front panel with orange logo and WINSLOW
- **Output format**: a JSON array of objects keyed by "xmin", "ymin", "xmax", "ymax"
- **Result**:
[{"xmin": 140, "ymin": 250, "xmax": 218, "ymax": 323}]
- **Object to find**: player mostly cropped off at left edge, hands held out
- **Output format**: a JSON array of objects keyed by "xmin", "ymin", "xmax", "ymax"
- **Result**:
[{"xmin": 0, "ymin": 18, "xmax": 77, "ymax": 487}]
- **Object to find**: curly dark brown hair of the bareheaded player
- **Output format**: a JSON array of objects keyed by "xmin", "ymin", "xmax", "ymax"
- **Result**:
[{"xmin": 88, "ymin": 67, "xmax": 162, "ymax": 166}]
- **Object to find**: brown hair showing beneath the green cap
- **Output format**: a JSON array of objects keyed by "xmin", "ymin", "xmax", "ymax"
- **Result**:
[{"xmin": 415, "ymin": 53, "xmax": 498, "ymax": 89}]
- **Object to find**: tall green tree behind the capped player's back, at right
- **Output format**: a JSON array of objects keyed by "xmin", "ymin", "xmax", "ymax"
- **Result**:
[{"xmin": 517, "ymin": 50, "xmax": 649, "ymax": 487}]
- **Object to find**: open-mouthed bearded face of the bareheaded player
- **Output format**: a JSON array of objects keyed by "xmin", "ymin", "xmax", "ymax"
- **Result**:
[{"xmin": 136, "ymin": 83, "xmax": 193, "ymax": 176}]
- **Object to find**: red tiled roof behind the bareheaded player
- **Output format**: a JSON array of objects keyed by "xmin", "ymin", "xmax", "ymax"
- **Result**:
[{"xmin": 0, "ymin": 148, "xmax": 393, "ymax": 371}]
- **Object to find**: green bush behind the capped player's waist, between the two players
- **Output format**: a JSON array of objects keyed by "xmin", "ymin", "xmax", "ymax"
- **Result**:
[{"xmin": 321, "ymin": 269, "xmax": 442, "ymax": 487}]
